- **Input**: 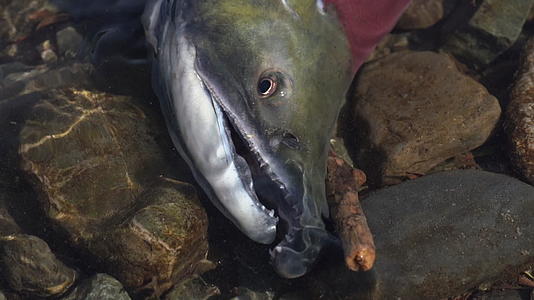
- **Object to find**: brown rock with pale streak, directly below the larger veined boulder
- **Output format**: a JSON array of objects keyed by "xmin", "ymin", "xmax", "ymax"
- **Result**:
[{"xmin": 88, "ymin": 182, "xmax": 208, "ymax": 295}]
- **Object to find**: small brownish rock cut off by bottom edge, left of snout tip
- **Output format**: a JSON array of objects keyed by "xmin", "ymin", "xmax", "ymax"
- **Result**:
[{"xmin": 165, "ymin": 276, "xmax": 221, "ymax": 300}]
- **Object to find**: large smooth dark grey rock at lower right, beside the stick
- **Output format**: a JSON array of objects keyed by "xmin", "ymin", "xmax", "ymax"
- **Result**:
[{"xmin": 358, "ymin": 171, "xmax": 534, "ymax": 299}]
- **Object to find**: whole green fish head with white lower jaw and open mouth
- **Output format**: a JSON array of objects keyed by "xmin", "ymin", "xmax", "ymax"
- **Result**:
[{"xmin": 143, "ymin": 0, "xmax": 353, "ymax": 278}]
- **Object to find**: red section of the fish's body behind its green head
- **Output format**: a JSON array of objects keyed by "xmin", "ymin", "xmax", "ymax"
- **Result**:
[{"xmin": 323, "ymin": 0, "xmax": 411, "ymax": 71}]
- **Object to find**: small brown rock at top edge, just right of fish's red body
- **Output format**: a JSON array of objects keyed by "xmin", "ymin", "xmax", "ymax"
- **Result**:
[{"xmin": 397, "ymin": 0, "xmax": 445, "ymax": 30}]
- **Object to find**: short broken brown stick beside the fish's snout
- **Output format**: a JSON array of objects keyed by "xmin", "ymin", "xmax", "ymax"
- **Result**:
[{"xmin": 326, "ymin": 153, "xmax": 376, "ymax": 271}]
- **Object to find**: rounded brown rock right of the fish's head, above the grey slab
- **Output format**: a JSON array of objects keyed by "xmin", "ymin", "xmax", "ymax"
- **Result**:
[{"xmin": 352, "ymin": 52, "xmax": 501, "ymax": 186}]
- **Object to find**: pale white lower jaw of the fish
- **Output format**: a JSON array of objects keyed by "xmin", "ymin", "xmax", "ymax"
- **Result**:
[{"xmin": 153, "ymin": 23, "xmax": 278, "ymax": 244}]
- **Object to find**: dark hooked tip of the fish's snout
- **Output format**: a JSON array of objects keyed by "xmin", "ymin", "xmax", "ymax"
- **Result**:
[{"xmin": 271, "ymin": 227, "xmax": 332, "ymax": 279}]
